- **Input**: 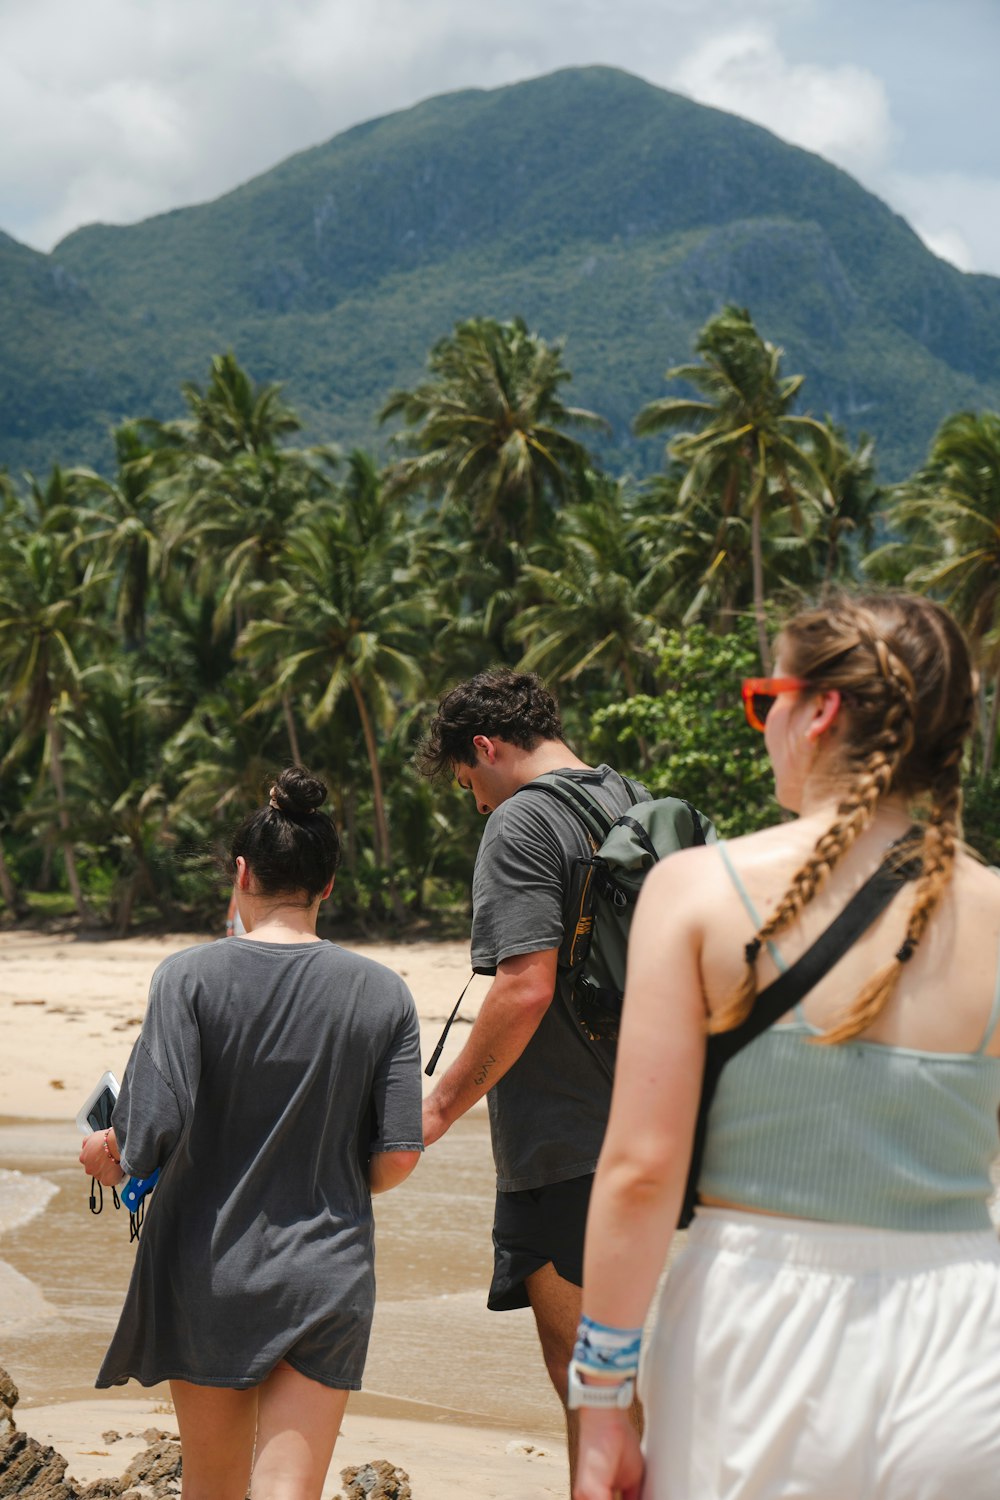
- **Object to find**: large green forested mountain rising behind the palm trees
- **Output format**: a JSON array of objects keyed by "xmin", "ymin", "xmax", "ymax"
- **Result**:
[{"xmin": 0, "ymin": 68, "xmax": 1000, "ymax": 477}]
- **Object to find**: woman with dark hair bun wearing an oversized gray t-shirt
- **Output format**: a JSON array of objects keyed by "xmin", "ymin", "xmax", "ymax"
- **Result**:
[{"xmin": 79, "ymin": 767, "xmax": 423, "ymax": 1500}]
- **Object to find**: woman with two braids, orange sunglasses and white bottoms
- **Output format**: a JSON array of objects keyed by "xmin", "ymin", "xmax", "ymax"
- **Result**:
[{"xmin": 570, "ymin": 594, "xmax": 1000, "ymax": 1500}]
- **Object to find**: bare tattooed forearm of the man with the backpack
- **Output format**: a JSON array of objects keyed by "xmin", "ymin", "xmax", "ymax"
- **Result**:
[{"xmin": 424, "ymin": 948, "xmax": 559, "ymax": 1146}]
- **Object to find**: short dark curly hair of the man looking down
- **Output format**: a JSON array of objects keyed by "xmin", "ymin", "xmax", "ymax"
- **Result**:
[{"xmin": 417, "ymin": 666, "xmax": 562, "ymax": 776}]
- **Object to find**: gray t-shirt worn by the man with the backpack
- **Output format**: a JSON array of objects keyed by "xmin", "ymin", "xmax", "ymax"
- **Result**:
[{"xmin": 472, "ymin": 765, "xmax": 648, "ymax": 1193}]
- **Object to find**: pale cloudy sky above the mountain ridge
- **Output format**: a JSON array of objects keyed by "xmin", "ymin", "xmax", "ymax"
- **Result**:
[{"xmin": 0, "ymin": 0, "xmax": 1000, "ymax": 275}]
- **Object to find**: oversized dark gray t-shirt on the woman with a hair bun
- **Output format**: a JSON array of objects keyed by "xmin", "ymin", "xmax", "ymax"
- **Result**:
[{"xmin": 97, "ymin": 938, "xmax": 423, "ymax": 1389}]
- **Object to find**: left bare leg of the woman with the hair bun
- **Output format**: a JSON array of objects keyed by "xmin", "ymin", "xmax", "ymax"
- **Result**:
[{"xmin": 169, "ymin": 1380, "xmax": 259, "ymax": 1500}]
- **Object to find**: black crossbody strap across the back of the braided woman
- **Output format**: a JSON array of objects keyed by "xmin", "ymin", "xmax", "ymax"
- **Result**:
[{"xmin": 678, "ymin": 825, "xmax": 922, "ymax": 1229}]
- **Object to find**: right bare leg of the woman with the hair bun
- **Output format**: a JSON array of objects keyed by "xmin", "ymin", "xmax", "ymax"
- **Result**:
[{"xmin": 248, "ymin": 1361, "xmax": 348, "ymax": 1500}]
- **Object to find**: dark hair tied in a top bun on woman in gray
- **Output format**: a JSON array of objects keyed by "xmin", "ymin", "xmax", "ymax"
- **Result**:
[{"xmin": 229, "ymin": 765, "xmax": 340, "ymax": 902}]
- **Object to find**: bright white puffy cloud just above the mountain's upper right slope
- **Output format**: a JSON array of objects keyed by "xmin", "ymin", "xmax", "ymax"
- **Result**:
[{"xmin": 669, "ymin": 26, "xmax": 894, "ymax": 173}]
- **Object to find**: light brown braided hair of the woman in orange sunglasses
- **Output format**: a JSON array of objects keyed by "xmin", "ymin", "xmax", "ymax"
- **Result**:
[{"xmin": 709, "ymin": 597, "xmax": 973, "ymax": 1043}]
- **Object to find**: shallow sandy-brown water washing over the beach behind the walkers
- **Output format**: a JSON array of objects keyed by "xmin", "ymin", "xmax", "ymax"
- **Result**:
[{"xmin": 0, "ymin": 1116, "xmax": 564, "ymax": 1437}]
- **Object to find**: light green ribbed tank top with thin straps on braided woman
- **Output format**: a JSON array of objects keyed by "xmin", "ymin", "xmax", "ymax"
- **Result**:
[{"xmin": 699, "ymin": 843, "xmax": 1000, "ymax": 1232}]
